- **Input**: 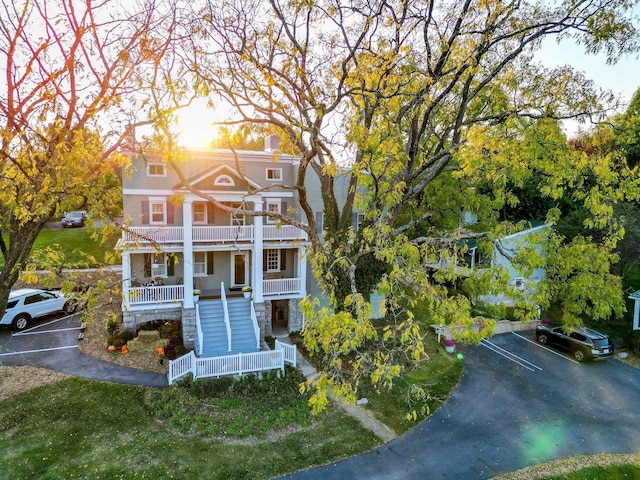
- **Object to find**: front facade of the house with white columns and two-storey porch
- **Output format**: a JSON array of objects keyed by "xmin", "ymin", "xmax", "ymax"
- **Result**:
[{"xmin": 117, "ymin": 137, "xmax": 308, "ymax": 352}]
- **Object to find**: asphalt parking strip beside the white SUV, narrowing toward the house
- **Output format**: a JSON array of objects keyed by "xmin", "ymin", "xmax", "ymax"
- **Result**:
[{"xmin": 0, "ymin": 314, "xmax": 167, "ymax": 387}]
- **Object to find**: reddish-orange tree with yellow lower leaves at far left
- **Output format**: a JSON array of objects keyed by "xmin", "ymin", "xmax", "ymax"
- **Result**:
[{"xmin": 0, "ymin": 0, "xmax": 182, "ymax": 312}]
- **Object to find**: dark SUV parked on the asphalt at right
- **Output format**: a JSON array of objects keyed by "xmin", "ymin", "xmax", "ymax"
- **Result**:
[{"xmin": 536, "ymin": 324, "xmax": 613, "ymax": 362}]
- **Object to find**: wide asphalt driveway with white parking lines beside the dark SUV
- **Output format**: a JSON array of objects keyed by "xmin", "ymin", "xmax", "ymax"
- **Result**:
[{"xmin": 287, "ymin": 332, "xmax": 640, "ymax": 480}]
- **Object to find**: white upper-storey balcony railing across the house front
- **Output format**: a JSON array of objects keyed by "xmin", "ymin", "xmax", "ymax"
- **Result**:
[{"xmin": 122, "ymin": 225, "xmax": 307, "ymax": 243}]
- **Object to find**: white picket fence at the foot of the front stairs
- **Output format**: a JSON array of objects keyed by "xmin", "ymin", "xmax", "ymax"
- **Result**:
[{"xmin": 167, "ymin": 340, "xmax": 296, "ymax": 385}]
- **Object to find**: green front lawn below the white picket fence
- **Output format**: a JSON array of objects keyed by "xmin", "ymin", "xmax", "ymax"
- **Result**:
[{"xmin": 0, "ymin": 378, "xmax": 379, "ymax": 480}]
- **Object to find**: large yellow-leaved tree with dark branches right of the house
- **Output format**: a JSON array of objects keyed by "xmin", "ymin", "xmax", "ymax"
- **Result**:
[{"xmin": 182, "ymin": 0, "xmax": 637, "ymax": 412}]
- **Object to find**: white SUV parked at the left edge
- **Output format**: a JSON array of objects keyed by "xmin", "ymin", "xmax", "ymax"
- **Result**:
[{"xmin": 0, "ymin": 288, "xmax": 76, "ymax": 330}]
